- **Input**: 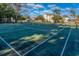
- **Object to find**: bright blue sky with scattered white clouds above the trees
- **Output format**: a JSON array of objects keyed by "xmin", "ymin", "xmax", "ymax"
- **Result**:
[{"xmin": 20, "ymin": 3, "xmax": 79, "ymax": 16}]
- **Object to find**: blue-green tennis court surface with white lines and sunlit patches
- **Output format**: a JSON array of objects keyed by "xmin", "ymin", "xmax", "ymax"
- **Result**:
[{"xmin": 0, "ymin": 23, "xmax": 79, "ymax": 56}]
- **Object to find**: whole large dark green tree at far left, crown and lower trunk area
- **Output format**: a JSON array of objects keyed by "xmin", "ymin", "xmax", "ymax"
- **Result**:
[{"xmin": 0, "ymin": 3, "xmax": 16, "ymax": 22}]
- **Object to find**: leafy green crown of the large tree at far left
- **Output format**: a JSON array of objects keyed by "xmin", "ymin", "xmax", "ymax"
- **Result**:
[{"xmin": 0, "ymin": 4, "xmax": 15, "ymax": 18}]
